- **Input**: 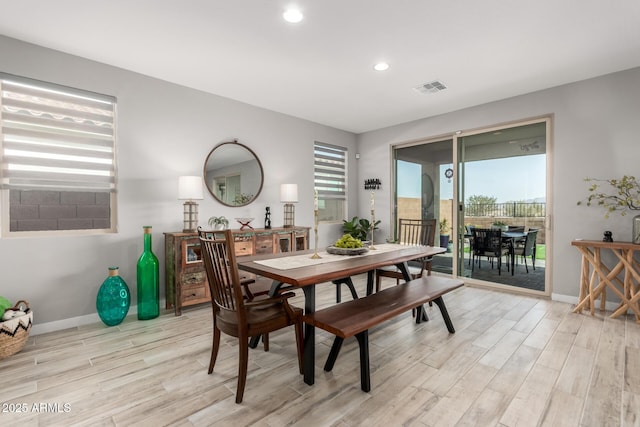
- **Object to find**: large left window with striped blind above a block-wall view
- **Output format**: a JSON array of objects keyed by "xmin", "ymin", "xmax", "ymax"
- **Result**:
[{"xmin": 0, "ymin": 73, "xmax": 116, "ymax": 236}]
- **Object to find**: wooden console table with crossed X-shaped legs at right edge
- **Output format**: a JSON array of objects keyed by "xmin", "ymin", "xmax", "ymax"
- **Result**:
[{"xmin": 571, "ymin": 240, "xmax": 640, "ymax": 323}]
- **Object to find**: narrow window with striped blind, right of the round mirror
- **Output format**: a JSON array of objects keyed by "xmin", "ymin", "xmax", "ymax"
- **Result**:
[{"xmin": 313, "ymin": 142, "xmax": 347, "ymax": 222}]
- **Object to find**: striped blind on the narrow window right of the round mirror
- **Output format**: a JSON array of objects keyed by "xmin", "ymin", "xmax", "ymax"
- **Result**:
[{"xmin": 314, "ymin": 142, "xmax": 347, "ymax": 200}]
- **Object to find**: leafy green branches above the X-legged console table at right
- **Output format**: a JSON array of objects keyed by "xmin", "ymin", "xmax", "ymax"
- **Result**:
[{"xmin": 578, "ymin": 175, "xmax": 640, "ymax": 218}]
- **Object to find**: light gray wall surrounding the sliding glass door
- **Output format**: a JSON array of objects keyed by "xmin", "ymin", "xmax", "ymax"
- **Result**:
[{"xmin": 358, "ymin": 68, "xmax": 640, "ymax": 301}]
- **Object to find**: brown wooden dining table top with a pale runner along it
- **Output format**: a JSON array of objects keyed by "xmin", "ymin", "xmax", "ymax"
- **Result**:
[{"xmin": 237, "ymin": 245, "xmax": 446, "ymax": 287}]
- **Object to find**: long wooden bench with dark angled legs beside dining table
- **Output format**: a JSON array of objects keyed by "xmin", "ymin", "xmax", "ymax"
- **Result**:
[{"xmin": 304, "ymin": 276, "xmax": 464, "ymax": 392}]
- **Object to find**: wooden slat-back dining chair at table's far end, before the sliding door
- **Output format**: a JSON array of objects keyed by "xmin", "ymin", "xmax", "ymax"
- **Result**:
[{"xmin": 375, "ymin": 218, "xmax": 436, "ymax": 292}]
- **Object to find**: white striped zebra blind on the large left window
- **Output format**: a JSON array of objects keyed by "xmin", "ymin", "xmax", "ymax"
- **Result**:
[{"xmin": 0, "ymin": 73, "xmax": 116, "ymax": 192}]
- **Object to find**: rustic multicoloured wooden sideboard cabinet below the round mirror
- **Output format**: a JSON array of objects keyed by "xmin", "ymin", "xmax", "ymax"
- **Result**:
[{"xmin": 164, "ymin": 227, "xmax": 309, "ymax": 316}]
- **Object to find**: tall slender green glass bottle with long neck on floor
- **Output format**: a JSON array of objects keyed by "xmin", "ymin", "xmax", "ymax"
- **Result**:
[{"xmin": 137, "ymin": 225, "xmax": 160, "ymax": 320}]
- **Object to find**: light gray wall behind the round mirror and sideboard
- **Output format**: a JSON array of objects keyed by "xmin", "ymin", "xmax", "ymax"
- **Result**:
[{"xmin": 0, "ymin": 36, "xmax": 357, "ymax": 333}]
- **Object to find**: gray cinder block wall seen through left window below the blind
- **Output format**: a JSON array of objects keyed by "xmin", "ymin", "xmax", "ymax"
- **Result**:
[{"xmin": 9, "ymin": 190, "xmax": 110, "ymax": 231}]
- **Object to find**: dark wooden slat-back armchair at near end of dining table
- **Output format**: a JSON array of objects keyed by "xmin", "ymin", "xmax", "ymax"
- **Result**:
[{"xmin": 198, "ymin": 227, "xmax": 303, "ymax": 403}]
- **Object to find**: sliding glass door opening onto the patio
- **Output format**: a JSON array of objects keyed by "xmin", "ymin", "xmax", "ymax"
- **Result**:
[{"xmin": 394, "ymin": 119, "xmax": 550, "ymax": 293}]
